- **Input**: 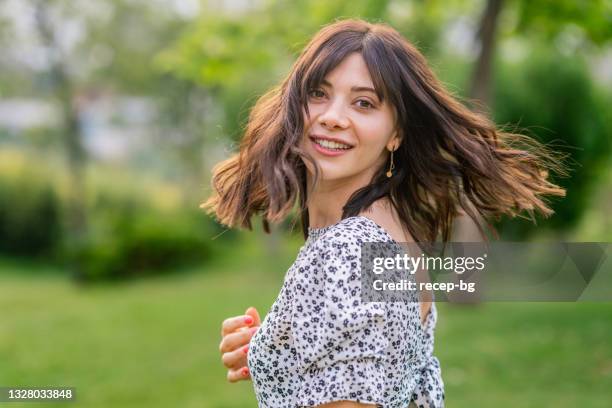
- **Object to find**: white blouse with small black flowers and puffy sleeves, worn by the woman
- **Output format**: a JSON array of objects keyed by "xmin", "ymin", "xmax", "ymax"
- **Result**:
[{"xmin": 247, "ymin": 216, "xmax": 444, "ymax": 408}]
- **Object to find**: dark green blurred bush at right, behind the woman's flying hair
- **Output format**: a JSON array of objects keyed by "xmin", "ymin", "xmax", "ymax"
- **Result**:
[{"xmin": 494, "ymin": 48, "xmax": 612, "ymax": 238}]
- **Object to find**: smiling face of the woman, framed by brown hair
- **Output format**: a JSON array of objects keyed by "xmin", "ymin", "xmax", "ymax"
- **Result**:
[{"xmin": 301, "ymin": 53, "xmax": 399, "ymax": 182}]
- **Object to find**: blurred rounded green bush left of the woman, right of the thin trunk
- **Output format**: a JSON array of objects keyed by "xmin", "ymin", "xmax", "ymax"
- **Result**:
[{"xmin": 69, "ymin": 190, "xmax": 212, "ymax": 281}]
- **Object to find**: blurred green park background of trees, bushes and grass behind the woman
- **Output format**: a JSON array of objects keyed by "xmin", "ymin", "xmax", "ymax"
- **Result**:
[{"xmin": 0, "ymin": 0, "xmax": 612, "ymax": 408}]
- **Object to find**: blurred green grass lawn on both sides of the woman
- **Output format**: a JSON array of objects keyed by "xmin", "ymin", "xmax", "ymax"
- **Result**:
[{"xmin": 0, "ymin": 242, "xmax": 612, "ymax": 408}]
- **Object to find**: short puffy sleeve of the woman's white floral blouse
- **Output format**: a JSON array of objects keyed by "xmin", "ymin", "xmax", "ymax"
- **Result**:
[{"xmin": 291, "ymin": 237, "xmax": 388, "ymax": 407}]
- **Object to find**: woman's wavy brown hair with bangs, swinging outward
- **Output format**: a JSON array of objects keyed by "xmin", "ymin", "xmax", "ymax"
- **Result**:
[{"xmin": 201, "ymin": 19, "xmax": 566, "ymax": 242}]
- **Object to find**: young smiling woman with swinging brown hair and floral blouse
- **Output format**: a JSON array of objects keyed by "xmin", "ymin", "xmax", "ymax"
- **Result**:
[{"xmin": 203, "ymin": 20, "xmax": 564, "ymax": 408}]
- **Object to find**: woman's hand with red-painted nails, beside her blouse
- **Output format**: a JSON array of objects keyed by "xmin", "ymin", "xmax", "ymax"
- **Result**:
[{"xmin": 219, "ymin": 307, "xmax": 261, "ymax": 382}]
